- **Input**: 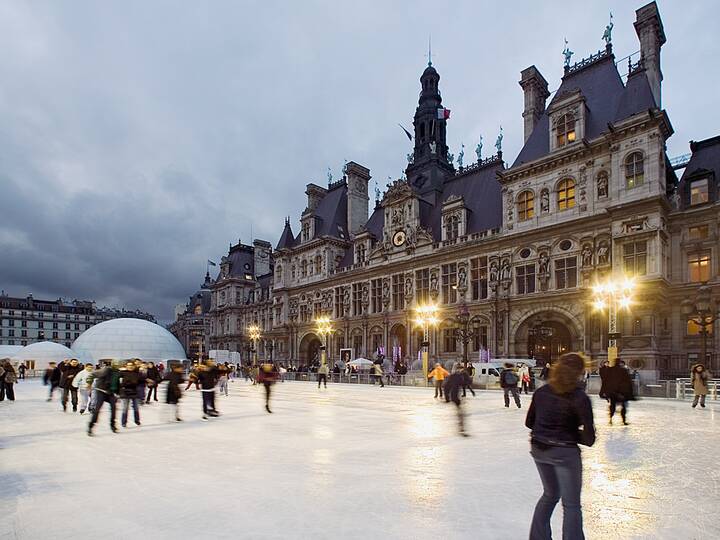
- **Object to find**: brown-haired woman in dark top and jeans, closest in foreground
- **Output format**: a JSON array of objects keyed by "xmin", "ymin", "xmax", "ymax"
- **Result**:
[{"xmin": 525, "ymin": 353, "xmax": 595, "ymax": 540}]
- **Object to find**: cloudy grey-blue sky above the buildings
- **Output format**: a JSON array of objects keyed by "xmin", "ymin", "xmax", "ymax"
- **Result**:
[{"xmin": 0, "ymin": 0, "xmax": 720, "ymax": 321}]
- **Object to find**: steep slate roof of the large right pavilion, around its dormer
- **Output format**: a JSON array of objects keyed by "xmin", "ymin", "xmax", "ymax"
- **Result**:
[{"xmin": 513, "ymin": 54, "xmax": 657, "ymax": 167}]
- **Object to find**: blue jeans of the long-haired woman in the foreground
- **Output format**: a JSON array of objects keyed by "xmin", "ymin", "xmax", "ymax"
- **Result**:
[{"xmin": 530, "ymin": 445, "xmax": 585, "ymax": 540}]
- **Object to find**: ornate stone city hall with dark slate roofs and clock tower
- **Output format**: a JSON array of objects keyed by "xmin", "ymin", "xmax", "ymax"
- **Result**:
[{"xmin": 194, "ymin": 2, "xmax": 720, "ymax": 379}]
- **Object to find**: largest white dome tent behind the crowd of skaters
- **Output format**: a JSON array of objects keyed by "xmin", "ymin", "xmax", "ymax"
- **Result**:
[{"xmin": 72, "ymin": 319, "xmax": 186, "ymax": 363}]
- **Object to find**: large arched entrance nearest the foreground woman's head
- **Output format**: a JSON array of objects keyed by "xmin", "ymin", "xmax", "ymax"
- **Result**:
[{"xmin": 515, "ymin": 312, "xmax": 581, "ymax": 365}]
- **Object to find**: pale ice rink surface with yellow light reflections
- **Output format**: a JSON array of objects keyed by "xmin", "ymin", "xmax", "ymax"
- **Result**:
[{"xmin": 0, "ymin": 381, "xmax": 720, "ymax": 540}]
